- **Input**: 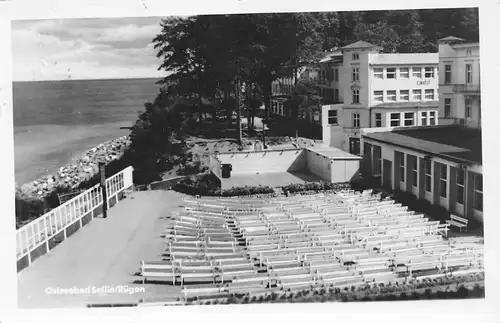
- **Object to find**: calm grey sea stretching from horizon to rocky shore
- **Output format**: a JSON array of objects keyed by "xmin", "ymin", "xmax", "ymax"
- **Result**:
[{"xmin": 13, "ymin": 78, "xmax": 160, "ymax": 185}]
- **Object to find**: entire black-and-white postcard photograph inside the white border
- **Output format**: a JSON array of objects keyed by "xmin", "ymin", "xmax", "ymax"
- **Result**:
[{"xmin": 2, "ymin": 1, "xmax": 494, "ymax": 316}]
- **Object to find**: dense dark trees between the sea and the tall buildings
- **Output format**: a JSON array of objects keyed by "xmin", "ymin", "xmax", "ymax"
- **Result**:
[{"xmin": 128, "ymin": 8, "xmax": 479, "ymax": 183}]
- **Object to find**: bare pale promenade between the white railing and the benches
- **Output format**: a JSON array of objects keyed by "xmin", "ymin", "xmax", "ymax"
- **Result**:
[{"xmin": 18, "ymin": 191, "xmax": 187, "ymax": 308}]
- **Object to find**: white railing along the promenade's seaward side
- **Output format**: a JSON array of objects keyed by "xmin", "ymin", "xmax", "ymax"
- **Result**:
[{"xmin": 16, "ymin": 166, "xmax": 133, "ymax": 266}]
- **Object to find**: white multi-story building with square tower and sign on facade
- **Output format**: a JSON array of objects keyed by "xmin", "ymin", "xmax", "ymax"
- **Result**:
[{"xmin": 321, "ymin": 41, "xmax": 439, "ymax": 154}]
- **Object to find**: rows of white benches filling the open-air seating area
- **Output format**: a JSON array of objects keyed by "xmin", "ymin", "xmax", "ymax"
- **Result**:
[{"xmin": 141, "ymin": 190, "xmax": 484, "ymax": 301}]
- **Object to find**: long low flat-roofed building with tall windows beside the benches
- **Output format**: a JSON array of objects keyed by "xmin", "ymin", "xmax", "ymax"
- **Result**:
[{"xmin": 361, "ymin": 125, "xmax": 483, "ymax": 222}]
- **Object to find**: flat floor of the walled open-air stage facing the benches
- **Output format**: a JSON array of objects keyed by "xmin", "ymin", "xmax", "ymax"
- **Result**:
[{"xmin": 222, "ymin": 172, "xmax": 321, "ymax": 189}]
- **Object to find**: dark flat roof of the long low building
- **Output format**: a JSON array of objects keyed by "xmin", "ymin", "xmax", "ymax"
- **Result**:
[{"xmin": 363, "ymin": 125, "xmax": 482, "ymax": 164}]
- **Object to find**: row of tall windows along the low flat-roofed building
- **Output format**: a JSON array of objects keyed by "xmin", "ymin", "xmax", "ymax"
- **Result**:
[{"xmin": 399, "ymin": 154, "xmax": 483, "ymax": 212}]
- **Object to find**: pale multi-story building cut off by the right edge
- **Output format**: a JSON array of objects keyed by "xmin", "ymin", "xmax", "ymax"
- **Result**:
[{"xmin": 439, "ymin": 37, "xmax": 481, "ymax": 127}]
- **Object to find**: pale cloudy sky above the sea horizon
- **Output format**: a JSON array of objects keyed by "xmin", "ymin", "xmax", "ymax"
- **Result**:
[{"xmin": 12, "ymin": 17, "xmax": 169, "ymax": 81}]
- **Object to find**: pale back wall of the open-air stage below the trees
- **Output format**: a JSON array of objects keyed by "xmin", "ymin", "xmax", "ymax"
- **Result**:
[{"xmin": 217, "ymin": 149, "xmax": 306, "ymax": 174}]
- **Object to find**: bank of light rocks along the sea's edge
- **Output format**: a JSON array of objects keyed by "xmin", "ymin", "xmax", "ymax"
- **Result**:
[{"xmin": 21, "ymin": 136, "xmax": 130, "ymax": 199}]
